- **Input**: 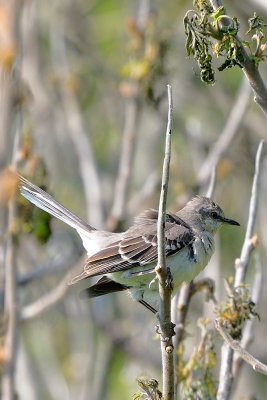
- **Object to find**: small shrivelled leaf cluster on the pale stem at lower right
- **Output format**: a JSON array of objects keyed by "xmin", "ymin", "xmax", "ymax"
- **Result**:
[{"xmin": 215, "ymin": 277, "xmax": 259, "ymax": 340}]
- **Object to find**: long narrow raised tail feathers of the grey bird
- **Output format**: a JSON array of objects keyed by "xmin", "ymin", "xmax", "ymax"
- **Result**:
[{"xmin": 19, "ymin": 176, "xmax": 95, "ymax": 236}]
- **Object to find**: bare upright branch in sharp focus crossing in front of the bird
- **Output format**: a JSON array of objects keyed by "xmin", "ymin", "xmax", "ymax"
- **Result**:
[{"xmin": 156, "ymin": 85, "xmax": 174, "ymax": 400}]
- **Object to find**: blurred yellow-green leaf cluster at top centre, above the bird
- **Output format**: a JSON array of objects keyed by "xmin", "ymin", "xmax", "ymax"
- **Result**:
[{"xmin": 121, "ymin": 16, "xmax": 169, "ymax": 106}]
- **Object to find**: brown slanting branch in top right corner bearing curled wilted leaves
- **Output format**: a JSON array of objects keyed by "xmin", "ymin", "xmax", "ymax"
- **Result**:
[{"xmin": 210, "ymin": 0, "xmax": 267, "ymax": 115}]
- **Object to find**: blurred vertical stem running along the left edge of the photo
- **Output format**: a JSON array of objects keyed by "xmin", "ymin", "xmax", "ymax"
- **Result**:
[{"xmin": 0, "ymin": 0, "xmax": 21, "ymax": 400}]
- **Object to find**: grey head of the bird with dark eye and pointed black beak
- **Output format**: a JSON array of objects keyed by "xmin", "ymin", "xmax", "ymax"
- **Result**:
[{"xmin": 179, "ymin": 196, "xmax": 240, "ymax": 235}]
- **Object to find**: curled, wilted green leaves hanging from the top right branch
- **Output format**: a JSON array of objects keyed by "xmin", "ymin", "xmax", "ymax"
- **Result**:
[{"xmin": 184, "ymin": 0, "xmax": 266, "ymax": 84}]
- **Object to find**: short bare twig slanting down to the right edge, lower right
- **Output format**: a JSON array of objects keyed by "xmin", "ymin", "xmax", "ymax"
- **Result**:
[{"xmin": 215, "ymin": 320, "xmax": 267, "ymax": 375}]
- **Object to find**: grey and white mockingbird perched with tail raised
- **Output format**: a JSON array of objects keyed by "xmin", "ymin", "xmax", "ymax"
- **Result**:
[{"xmin": 20, "ymin": 178, "xmax": 239, "ymax": 312}]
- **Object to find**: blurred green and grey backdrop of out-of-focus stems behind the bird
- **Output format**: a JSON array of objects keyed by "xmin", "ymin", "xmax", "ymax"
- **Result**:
[{"xmin": 0, "ymin": 0, "xmax": 267, "ymax": 400}]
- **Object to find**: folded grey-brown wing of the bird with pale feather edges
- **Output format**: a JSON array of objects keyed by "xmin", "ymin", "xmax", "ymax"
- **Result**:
[{"xmin": 71, "ymin": 210, "xmax": 194, "ymax": 283}]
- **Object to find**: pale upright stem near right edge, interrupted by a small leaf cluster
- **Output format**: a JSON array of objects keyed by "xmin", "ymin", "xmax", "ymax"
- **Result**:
[{"xmin": 217, "ymin": 141, "xmax": 264, "ymax": 400}]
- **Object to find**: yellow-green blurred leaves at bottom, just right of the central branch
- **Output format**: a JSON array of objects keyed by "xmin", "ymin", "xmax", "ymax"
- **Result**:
[{"xmin": 177, "ymin": 318, "xmax": 217, "ymax": 400}]
